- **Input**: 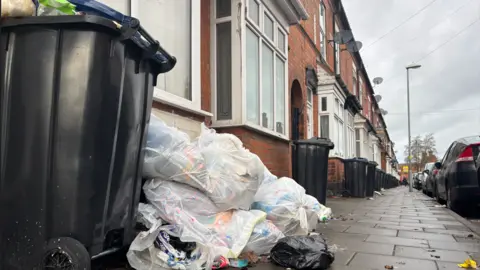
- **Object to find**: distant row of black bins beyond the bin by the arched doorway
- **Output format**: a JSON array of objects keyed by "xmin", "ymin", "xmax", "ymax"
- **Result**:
[{"xmin": 344, "ymin": 158, "xmax": 398, "ymax": 198}]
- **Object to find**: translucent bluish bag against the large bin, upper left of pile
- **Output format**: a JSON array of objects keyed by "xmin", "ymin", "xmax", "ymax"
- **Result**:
[{"xmin": 143, "ymin": 114, "xmax": 212, "ymax": 192}]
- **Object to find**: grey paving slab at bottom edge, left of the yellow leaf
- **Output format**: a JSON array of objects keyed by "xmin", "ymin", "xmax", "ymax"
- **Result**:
[{"xmin": 348, "ymin": 253, "xmax": 437, "ymax": 270}]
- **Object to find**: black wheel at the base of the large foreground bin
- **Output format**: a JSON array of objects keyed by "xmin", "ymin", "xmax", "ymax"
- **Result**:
[{"xmin": 41, "ymin": 237, "xmax": 91, "ymax": 270}]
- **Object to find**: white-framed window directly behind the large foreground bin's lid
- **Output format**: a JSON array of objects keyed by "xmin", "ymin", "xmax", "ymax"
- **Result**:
[{"xmin": 135, "ymin": 0, "xmax": 201, "ymax": 110}]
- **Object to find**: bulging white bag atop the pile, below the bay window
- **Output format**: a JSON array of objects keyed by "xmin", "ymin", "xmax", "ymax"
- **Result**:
[{"xmin": 197, "ymin": 125, "xmax": 265, "ymax": 211}]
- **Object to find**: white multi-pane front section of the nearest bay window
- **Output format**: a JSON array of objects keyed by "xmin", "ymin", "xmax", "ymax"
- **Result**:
[{"xmin": 246, "ymin": 0, "xmax": 287, "ymax": 134}]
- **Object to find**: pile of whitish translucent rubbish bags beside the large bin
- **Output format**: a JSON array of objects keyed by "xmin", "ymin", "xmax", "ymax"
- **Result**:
[{"xmin": 127, "ymin": 115, "xmax": 331, "ymax": 270}]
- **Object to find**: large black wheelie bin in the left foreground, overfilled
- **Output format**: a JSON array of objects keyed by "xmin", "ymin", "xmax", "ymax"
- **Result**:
[{"xmin": 0, "ymin": 15, "xmax": 176, "ymax": 270}]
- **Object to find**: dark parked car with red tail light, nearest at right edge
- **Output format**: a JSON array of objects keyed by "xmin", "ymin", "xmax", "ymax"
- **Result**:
[{"xmin": 435, "ymin": 136, "xmax": 480, "ymax": 214}]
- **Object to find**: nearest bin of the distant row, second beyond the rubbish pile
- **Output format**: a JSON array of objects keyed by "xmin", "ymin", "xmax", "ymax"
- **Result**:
[{"xmin": 344, "ymin": 158, "xmax": 368, "ymax": 198}]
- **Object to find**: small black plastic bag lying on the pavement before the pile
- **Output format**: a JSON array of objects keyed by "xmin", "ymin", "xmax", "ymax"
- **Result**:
[{"xmin": 270, "ymin": 235, "xmax": 335, "ymax": 270}]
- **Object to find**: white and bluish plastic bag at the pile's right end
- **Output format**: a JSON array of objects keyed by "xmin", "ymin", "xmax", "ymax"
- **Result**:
[{"xmin": 252, "ymin": 177, "xmax": 318, "ymax": 236}]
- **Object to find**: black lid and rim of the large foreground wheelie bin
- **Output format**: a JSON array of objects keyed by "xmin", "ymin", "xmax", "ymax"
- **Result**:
[{"xmin": 2, "ymin": 15, "xmax": 177, "ymax": 76}]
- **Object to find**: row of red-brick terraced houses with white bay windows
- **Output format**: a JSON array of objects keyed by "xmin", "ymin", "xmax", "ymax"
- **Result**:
[{"xmin": 103, "ymin": 0, "xmax": 402, "ymax": 186}]
